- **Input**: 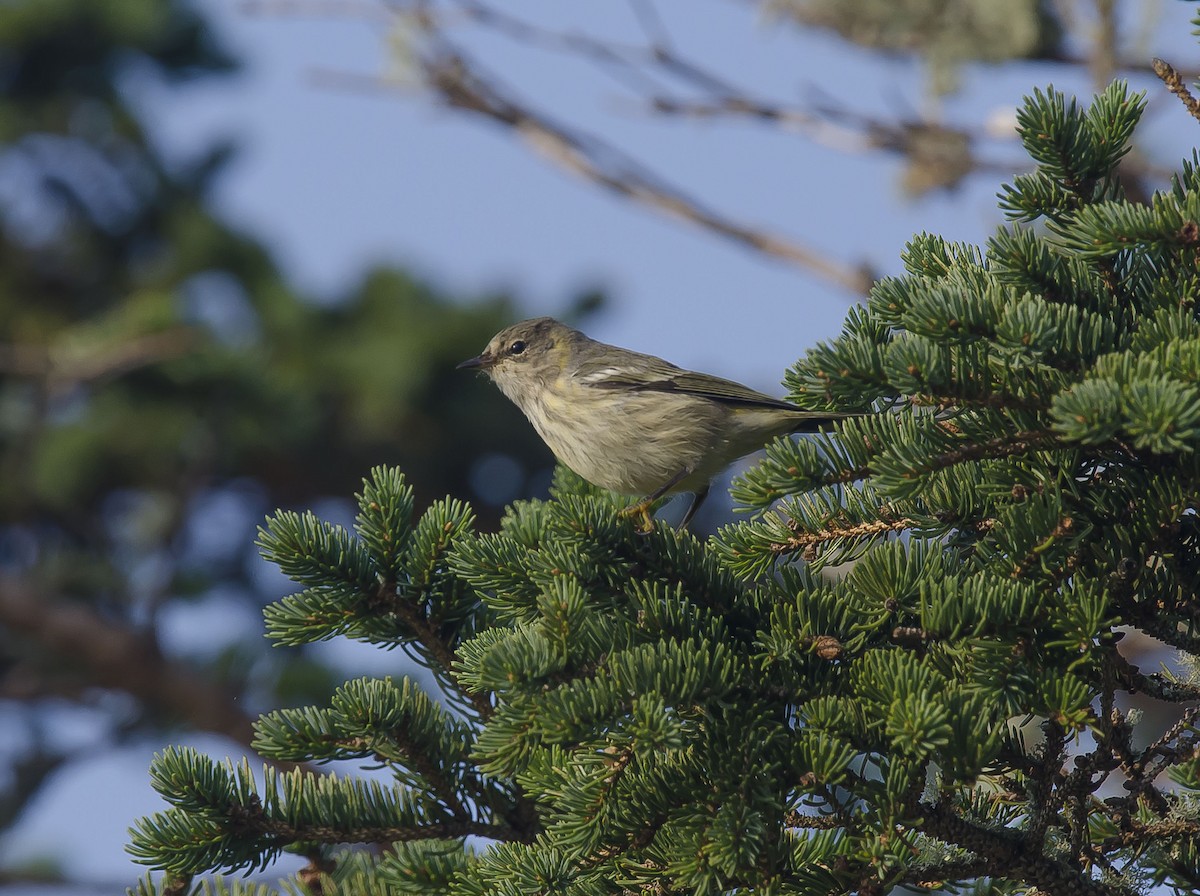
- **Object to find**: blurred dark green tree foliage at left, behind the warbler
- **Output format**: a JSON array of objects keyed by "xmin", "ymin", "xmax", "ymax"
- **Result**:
[{"xmin": 0, "ymin": 0, "xmax": 568, "ymax": 858}]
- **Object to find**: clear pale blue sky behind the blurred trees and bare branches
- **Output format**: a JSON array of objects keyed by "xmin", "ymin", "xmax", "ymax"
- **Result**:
[{"xmin": 0, "ymin": 0, "xmax": 1196, "ymax": 892}]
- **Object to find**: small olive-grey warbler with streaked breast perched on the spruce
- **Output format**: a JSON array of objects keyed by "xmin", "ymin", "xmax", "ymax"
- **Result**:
[{"xmin": 458, "ymin": 318, "xmax": 850, "ymax": 533}]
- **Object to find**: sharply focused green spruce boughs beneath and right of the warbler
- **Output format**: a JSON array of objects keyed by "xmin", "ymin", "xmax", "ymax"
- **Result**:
[{"xmin": 130, "ymin": 73, "xmax": 1200, "ymax": 896}]
